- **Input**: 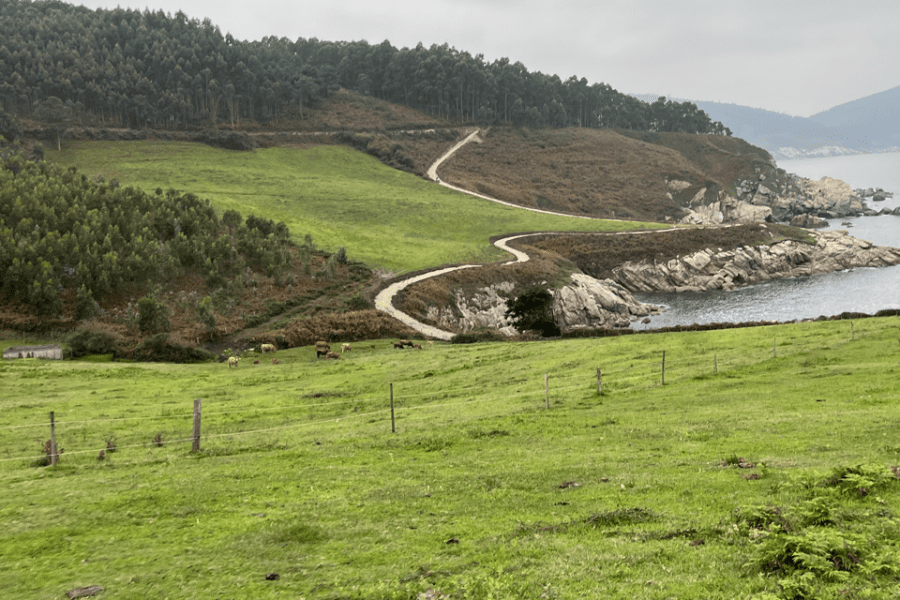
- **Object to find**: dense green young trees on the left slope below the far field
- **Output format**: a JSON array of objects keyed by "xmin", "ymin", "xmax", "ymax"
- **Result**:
[{"xmin": 0, "ymin": 145, "xmax": 294, "ymax": 319}]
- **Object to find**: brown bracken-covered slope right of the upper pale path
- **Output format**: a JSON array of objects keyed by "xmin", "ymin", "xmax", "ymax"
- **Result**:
[{"xmin": 440, "ymin": 127, "xmax": 771, "ymax": 222}]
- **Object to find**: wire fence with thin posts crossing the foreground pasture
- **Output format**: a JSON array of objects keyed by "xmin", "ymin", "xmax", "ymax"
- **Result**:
[{"xmin": 0, "ymin": 318, "xmax": 884, "ymax": 465}]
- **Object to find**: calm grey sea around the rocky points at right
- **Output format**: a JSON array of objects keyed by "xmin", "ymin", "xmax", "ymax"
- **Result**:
[{"xmin": 632, "ymin": 152, "xmax": 900, "ymax": 329}]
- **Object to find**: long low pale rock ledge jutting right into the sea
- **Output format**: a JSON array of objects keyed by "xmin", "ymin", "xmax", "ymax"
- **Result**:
[{"xmin": 613, "ymin": 230, "xmax": 900, "ymax": 292}]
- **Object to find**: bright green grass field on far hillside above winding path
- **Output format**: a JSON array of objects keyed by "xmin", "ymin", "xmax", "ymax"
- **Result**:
[{"xmin": 47, "ymin": 141, "xmax": 660, "ymax": 272}]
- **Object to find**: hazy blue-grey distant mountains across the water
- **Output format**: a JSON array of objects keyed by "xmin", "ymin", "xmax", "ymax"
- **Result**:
[{"xmin": 634, "ymin": 86, "xmax": 900, "ymax": 159}]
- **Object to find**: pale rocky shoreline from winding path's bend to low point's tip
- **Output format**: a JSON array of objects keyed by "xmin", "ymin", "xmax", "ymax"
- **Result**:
[{"xmin": 425, "ymin": 230, "xmax": 900, "ymax": 336}]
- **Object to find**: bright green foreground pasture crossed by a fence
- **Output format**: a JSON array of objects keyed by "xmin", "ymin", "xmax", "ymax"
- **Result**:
[{"xmin": 0, "ymin": 318, "xmax": 900, "ymax": 600}]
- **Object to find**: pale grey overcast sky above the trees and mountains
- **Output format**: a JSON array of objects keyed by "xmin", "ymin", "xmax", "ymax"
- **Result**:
[{"xmin": 77, "ymin": 0, "xmax": 900, "ymax": 117}]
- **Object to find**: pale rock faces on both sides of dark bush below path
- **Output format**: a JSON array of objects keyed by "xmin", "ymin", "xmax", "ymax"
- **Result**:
[{"xmin": 425, "ymin": 273, "xmax": 660, "ymax": 336}]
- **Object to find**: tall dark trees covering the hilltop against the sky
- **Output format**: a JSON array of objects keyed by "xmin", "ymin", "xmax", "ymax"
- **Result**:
[{"xmin": 0, "ymin": 0, "xmax": 731, "ymax": 135}]
